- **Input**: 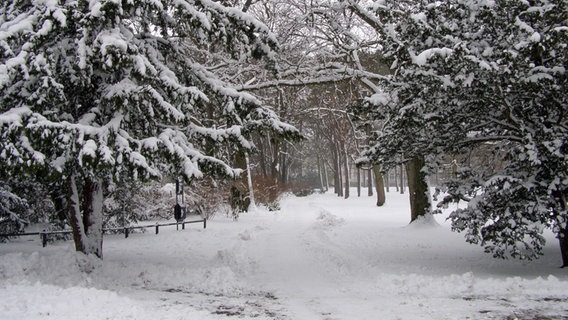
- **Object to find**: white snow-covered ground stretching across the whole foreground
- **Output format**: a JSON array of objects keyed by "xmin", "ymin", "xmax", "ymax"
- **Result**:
[{"xmin": 0, "ymin": 192, "xmax": 568, "ymax": 320}]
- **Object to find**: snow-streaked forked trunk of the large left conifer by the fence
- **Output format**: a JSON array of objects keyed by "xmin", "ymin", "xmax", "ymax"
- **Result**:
[{"xmin": 67, "ymin": 174, "xmax": 103, "ymax": 259}]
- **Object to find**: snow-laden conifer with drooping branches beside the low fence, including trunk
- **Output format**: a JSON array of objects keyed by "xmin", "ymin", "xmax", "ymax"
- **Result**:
[{"xmin": 0, "ymin": 0, "xmax": 297, "ymax": 257}]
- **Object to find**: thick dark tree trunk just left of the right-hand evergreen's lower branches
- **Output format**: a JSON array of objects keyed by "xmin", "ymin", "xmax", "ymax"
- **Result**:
[{"xmin": 406, "ymin": 157, "xmax": 432, "ymax": 223}]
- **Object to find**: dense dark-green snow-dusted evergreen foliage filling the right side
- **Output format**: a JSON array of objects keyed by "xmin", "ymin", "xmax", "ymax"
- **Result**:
[{"xmin": 348, "ymin": 0, "xmax": 568, "ymax": 266}]
